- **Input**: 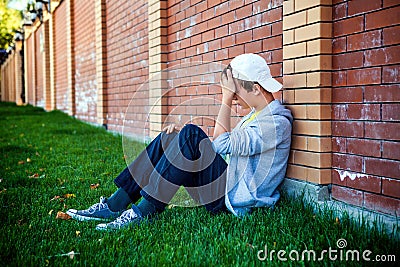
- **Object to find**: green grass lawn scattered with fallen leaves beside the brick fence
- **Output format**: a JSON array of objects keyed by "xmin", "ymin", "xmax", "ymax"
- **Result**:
[{"xmin": 0, "ymin": 103, "xmax": 400, "ymax": 266}]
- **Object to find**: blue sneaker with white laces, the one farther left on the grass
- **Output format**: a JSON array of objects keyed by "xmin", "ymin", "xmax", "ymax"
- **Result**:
[{"xmin": 67, "ymin": 197, "xmax": 121, "ymax": 221}]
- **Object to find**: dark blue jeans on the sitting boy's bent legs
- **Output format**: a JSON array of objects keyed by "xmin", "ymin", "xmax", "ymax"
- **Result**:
[{"xmin": 114, "ymin": 124, "xmax": 227, "ymax": 213}]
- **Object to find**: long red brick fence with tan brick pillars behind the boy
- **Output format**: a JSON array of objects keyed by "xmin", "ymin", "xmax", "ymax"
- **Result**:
[{"xmin": 1, "ymin": 0, "xmax": 400, "ymax": 218}]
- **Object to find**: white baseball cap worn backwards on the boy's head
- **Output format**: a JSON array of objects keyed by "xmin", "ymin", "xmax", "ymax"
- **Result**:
[{"xmin": 230, "ymin": 54, "xmax": 282, "ymax": 93}]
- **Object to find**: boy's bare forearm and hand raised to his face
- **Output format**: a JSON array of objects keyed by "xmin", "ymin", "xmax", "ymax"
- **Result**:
[{"xmin": 213, "ymin": 69, "xmax": 236, "ymax": 140}]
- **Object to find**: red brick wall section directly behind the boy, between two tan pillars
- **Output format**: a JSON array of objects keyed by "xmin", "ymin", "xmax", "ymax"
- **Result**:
[{"xmin": 167, "ymin": 0, "xmax": 283, "ymax": 135}]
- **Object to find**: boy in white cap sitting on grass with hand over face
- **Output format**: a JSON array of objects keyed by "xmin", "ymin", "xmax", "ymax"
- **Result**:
[{"xmin": 67, "ymin": 54, "xmax": 292, "ymax": 230}]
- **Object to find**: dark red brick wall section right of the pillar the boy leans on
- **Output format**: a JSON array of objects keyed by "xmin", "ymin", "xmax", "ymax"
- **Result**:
[{"xmin": 332, "ymin": 0, "xmax": 400, "ymax": 215}]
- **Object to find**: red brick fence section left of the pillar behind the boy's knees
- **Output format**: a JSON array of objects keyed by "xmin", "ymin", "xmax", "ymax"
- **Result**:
[{"xmin": 105, "ymin": 0, "xmax": 149, "ymax": 135}]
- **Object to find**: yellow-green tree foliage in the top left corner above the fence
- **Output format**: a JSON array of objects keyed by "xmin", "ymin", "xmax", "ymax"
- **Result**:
[{"xmin": 0, "ymin": 0, "xmax": 22, "ymax": 49}]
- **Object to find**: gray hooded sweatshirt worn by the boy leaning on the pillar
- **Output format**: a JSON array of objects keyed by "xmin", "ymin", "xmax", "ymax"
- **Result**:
[{"xmin": 213, "ymin": 100, "xmax": 293, "ymax": 216}]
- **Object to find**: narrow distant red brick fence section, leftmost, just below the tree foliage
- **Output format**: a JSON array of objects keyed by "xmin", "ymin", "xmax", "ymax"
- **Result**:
[{"xmin": 25, "ymin": 34, "xmax": 35, "ymax": 105}]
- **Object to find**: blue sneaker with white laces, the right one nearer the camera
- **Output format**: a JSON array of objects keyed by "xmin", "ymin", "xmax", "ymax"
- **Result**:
[{"xmin": 96, "ymin": 205, "xmax": 143, "ymax": 230}]
